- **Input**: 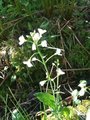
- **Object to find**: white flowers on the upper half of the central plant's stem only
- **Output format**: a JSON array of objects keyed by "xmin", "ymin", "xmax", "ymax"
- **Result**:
[{"xmin": 19, "ymin": 28, "xmax": 63, "ymax": 67}]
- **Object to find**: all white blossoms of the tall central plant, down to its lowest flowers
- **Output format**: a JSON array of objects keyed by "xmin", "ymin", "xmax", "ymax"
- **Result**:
[{"xmin": 19, "ymin": 28, "xmax": 65, "ymax": 86}]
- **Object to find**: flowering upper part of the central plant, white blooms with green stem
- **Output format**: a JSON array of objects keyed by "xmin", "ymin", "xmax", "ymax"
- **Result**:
[{"xmin": 19, "ymin": 28, "xmax": 65, "ymax": 86}]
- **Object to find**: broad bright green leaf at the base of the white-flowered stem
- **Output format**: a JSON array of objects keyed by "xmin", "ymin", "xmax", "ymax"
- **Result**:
[{"xmin": 35, "ymin": 92, "xmax": 55, "ymax": 110}]
